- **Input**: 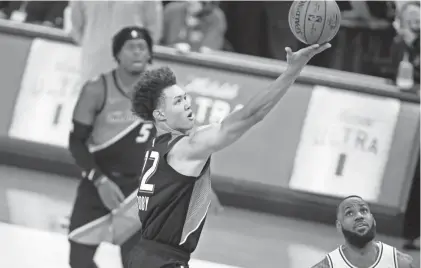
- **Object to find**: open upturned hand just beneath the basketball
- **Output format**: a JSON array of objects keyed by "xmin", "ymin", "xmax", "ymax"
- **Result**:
[{"xmin": 285, "ymin": 43, "xmax": 331, "ymax": 69}]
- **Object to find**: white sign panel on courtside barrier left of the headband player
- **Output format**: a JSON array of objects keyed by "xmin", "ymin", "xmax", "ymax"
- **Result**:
[{"xmin": 9, "ymin": 39, "xmax": 81, "ymax": 147}]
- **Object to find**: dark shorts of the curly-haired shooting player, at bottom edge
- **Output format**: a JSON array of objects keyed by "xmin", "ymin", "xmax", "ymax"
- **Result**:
[{"xmin": 125, "ymin": 239, "xmax": 190, "ymax": 268}]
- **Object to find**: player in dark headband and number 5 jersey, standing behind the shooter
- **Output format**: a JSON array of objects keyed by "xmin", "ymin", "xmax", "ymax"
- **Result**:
[{"xmin": 69, "ymin": 27, "xmax": 156, "ymax": 268}]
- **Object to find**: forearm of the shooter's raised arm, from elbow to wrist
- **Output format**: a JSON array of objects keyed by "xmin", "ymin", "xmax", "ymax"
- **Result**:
[{"xmin": 243, "ymin": 67, "xmax": 302, "ymax": 121}]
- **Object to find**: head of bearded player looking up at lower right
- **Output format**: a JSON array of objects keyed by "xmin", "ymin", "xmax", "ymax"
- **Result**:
[{"xmin": 337, "ymin": 197, "xmax": 376, "ymax": 248}]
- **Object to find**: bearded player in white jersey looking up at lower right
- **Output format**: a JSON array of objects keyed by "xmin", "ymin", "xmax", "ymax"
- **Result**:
[{"xmin": 312, "ymin": 195, "xmax": 415, "ymax": 268}]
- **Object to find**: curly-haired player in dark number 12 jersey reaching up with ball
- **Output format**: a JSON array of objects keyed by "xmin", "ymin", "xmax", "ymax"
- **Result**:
[{"xmin": 127, "ymin": 44, "xmax": 330, "ymax": 268}]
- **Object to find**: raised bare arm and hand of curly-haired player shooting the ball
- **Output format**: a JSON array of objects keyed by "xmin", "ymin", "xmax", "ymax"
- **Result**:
[{"xmin": 174, "ymin": 44, "xmax": 330, "ymax": 160}]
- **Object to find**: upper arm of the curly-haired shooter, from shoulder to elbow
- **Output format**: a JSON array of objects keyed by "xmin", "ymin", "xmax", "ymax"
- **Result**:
[{"xmin": 174, "ymin": 109, "xmax": 261, "ymax": 160}]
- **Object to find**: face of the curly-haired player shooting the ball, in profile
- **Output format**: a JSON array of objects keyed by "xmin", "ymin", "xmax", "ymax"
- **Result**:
[{"xmin": 161, "ymin": 85, "xmax": 194, "ymax": 132}]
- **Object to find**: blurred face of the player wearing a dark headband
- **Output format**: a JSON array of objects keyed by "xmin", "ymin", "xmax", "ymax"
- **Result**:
[{"xmin": 118, "ymin": 39, "xmax": 151, "ymax": 74}]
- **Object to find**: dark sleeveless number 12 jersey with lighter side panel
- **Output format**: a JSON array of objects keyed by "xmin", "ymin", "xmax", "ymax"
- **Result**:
[{"xmin": 138, "ymin": 133, "xmax": 211, "ymax": 255}]
